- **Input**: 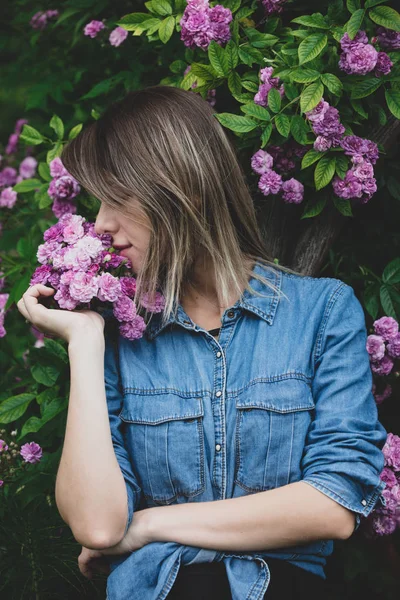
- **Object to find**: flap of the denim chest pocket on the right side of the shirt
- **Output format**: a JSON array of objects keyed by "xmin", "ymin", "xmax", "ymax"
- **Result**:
[{"xmin": 236, "ymin": 377, "xmax": 315, "ymax": 413}]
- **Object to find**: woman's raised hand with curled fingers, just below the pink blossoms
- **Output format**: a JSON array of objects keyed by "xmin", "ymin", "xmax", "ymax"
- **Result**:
[{"xmin": 17, "ymin": 283, "xmax": 105, "ymax": 343}]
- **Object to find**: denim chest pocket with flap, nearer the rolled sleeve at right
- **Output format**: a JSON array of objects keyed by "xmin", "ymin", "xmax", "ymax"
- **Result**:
[{"xmin": 235, "ymin": 378, "xmax": 315, "ymax": 492}]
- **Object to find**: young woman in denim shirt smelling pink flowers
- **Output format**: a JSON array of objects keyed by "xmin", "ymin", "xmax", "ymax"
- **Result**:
[{"xmin": 18, "ymin": 86, "xmax": 386, "ymax": 600}]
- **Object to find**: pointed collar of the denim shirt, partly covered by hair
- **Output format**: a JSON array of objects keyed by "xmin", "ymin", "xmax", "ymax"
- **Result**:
[{"xmin": 145, "ymin": 262, "xmax": 282, "ymax": 340}]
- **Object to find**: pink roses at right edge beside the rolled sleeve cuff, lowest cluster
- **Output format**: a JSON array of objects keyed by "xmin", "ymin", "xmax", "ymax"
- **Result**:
[{"xmin": 368, "ymin": 433, "xmax": 400, "ymax": 536}]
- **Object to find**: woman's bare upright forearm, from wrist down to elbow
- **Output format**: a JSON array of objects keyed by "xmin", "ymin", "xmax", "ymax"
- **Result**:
[{"xmin": 56, "ymin": 335, "xmax": 127, "ymax": 548}]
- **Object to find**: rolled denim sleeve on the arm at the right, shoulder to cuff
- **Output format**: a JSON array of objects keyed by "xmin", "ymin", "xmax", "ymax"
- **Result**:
[{"xmin": 302, "ymin": 282, "xmax": 386, "ymax": 528}]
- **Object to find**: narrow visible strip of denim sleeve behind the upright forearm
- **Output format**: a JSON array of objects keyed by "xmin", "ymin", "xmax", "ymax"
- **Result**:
[{"xmin": 104, "ymin": 324, "xmax": 141, "ymax": 536}]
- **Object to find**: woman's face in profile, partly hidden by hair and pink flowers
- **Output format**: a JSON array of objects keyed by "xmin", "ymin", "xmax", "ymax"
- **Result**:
[{"xmin": 95, "ymin": 202, "xmax": 151, "ymax": 274}]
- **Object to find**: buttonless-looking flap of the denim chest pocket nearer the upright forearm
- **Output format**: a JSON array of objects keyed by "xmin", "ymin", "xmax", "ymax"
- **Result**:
[{"xmin": 119, "ymin": 392, "xmax": 204, "ymax": 425}]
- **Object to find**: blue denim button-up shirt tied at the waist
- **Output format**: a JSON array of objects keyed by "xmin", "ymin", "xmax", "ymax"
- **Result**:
[{"xmin": 105, "ymin": 262, "xmax": 386, "ymax": 600}]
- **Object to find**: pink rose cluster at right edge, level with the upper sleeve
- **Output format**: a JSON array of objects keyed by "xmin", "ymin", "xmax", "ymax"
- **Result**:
[{"xmin": 367, "ymin": 317, "xmax": 400, "ymax": 375}]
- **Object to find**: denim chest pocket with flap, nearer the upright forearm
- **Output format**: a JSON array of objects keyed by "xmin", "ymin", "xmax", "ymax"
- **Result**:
[{"xmin": 119, "ymin": 391, "xmax": 205, "ymax": 504}]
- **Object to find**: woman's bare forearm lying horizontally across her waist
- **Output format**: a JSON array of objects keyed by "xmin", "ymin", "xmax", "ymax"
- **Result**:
[{"xmin": 148, "ymin": 481, "xmax": 355, "ymax": 551}]
